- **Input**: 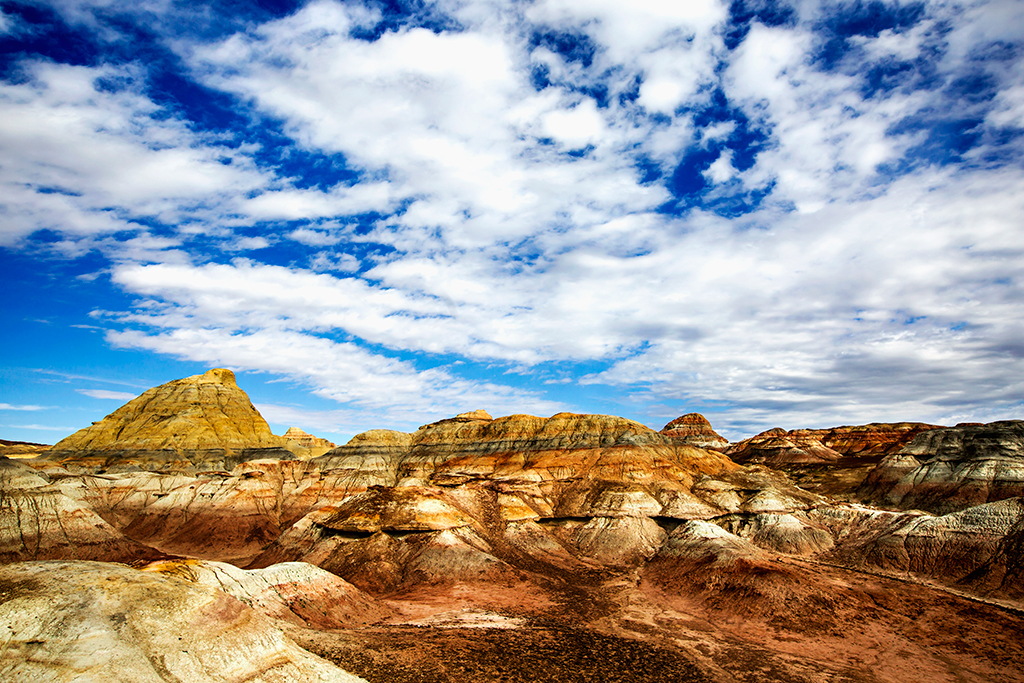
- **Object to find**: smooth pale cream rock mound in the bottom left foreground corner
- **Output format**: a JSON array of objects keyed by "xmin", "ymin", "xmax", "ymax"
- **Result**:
[{"xmin": 0, "ymin": 562, "xmax": 364, "ymax": 683}]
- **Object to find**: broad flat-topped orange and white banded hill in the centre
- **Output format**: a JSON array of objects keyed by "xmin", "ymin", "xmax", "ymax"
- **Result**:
[{"xmin": 253, "ymin": 413, "xmax": 819, "ymax": 592}]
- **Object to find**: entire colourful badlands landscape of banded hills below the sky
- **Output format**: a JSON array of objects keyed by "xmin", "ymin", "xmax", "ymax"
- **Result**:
[{"xmin": 0, "ymin": 370, "xmax": 1024, "ymax": 683}]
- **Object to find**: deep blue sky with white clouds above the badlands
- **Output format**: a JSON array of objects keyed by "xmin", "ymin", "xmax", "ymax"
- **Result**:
[{"xmin": 0, "ymin": 0, "xmax": 1024, "ymax": 443}]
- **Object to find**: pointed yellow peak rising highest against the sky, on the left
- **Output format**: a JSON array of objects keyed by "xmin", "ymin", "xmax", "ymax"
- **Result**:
[{"xmin": 43, "ymin": 369, "xmax": 294, "ymax": 472}]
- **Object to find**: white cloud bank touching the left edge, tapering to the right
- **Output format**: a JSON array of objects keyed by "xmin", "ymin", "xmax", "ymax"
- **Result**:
[{"xmin": 0, "ymin": 61, "xmax": 265, "ymax": 245}]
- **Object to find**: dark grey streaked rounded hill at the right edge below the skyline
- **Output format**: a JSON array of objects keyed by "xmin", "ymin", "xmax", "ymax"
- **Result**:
[{"xmin": 861, "ymin": 420, "xmax": 1024, "ymax": 513}]
